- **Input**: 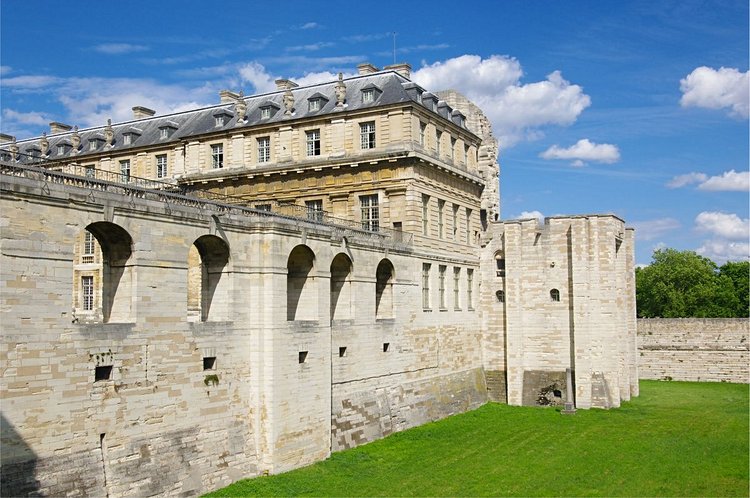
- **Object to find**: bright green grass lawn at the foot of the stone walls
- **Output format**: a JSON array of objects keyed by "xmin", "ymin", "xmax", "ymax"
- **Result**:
[{"xmin": 207, "ymin": 381, "xmax": 750, "ymax": 496}]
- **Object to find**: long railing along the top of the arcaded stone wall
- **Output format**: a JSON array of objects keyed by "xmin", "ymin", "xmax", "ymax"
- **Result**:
[{"xmin": 0, "ymin": 150, "xmax": 413, "ymax": 246}]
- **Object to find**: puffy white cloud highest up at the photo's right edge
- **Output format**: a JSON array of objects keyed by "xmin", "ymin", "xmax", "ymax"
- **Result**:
[{"xmin": 680, "ymin": 66, "xmax": 750, "ymax": 118}]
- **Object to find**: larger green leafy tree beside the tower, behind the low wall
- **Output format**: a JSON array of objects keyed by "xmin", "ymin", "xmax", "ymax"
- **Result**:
[{"xmin": 635, "ymin": 249, "xmax": 747, "ymax": 318}]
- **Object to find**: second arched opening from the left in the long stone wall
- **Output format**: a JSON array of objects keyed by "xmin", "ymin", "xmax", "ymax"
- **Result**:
[{"xmin": 187, "ymin": 235, "xmax": 229, "ymax": 322}]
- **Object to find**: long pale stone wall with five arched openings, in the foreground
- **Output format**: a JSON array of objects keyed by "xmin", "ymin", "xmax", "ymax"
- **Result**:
[{"xmin": 0, "ymin": 169, "xmax": 487, "ymax": 496}]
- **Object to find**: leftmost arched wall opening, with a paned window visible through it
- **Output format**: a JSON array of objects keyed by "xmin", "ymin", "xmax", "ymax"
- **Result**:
[{"xmin": 73, "ymin": 221, "xmax": 133, "ymax": 323}]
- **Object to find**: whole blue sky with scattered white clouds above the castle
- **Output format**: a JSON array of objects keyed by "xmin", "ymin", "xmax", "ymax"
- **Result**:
[{"xmin": 0, "ymin": 0, "xmax": 750, "ymax": 264}]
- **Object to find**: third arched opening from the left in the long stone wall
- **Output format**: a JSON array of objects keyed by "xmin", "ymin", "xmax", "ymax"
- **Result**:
[{"xmin": 286, "ymin": 244, "xmax": 318, "ymax": 321}]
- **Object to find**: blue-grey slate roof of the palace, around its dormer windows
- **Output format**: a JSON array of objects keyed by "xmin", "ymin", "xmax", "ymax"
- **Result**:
[{"xmin": 0, "ymin": 70, "xmax": 473, "ymax": 162}]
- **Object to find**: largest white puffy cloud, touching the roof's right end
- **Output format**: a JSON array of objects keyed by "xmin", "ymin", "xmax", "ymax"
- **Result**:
[{"xmin": 412, "ymin": 55, "xmax": 591, "ymax": 147}]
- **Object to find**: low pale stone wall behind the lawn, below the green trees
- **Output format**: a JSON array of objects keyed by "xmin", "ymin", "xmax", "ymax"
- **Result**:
[{"xmin": 638, "ymin": 318, "xmax": 750, "ymax": 383}]
